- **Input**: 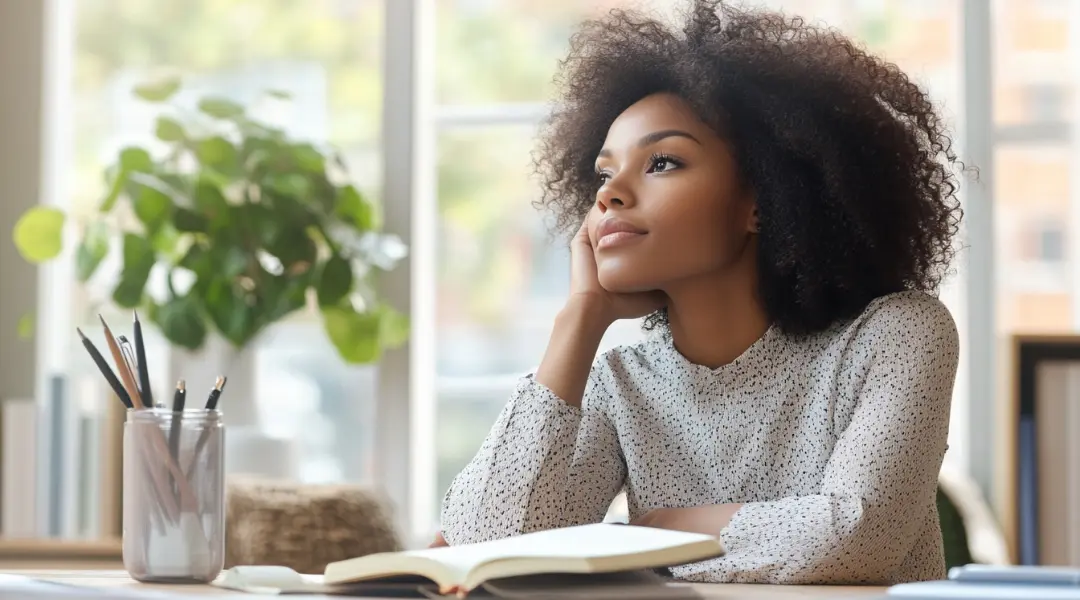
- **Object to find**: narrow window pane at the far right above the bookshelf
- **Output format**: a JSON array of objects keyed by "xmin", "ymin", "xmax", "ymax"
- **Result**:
[{"xmin": 993, "ymin": 0, "xmax": 1080, "ymax": 336}]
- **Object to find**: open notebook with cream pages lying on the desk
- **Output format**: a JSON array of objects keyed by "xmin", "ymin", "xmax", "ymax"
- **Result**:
[{"xmin": 219, "ymin": 523, "xmax": 724, "ymax": 595}]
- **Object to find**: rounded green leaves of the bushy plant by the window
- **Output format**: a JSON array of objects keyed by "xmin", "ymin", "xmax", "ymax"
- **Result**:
[{"xmin": 14, "ymin": 80, "xmax": 408, "ymax": 427}]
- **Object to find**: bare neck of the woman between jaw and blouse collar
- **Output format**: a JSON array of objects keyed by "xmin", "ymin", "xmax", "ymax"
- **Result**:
[{"xmin": 667, "ymin": 263, "xmax": 770, "ymax": 369}]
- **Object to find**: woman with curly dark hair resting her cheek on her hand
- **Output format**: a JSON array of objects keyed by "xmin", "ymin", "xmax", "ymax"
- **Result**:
[{"xmin": 436, "ymin": 0, "xmax": 960, "ymax": 584}]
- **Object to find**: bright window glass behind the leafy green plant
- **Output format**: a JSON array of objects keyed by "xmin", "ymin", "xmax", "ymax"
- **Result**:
[{"xmin": 43, "ymin": 0, "xmax": 383, "ymax": 535}]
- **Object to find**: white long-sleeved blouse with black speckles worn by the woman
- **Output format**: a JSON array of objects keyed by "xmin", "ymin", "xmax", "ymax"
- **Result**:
[{"xmin": 442, "ymin": 291, "xmax": 958, "ymax": 584}]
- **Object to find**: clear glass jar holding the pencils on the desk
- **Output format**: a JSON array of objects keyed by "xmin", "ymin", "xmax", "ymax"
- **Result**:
[{"xmin": 123, "ymin": 409, "xmax": 225, "ymax": 583}]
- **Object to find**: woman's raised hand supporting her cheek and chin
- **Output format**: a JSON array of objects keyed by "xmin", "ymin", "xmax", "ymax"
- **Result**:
[{"xmin": 568, "ymin": 219, "xmax": 667, "ymax": 327}]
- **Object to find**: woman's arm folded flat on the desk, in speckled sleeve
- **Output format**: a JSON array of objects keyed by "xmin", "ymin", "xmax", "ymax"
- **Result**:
[{"xmin": 640, "ymin": 299, "xmax": 959, "ymax": 584}]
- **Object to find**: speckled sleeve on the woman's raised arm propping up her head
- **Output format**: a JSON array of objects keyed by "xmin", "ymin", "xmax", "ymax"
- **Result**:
[{"xmin": 442, "ymin": 366, "xmax": 626, "ymax": 545}]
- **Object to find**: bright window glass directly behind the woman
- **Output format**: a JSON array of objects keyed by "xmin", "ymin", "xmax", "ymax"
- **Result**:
[{"xmin": 431, "ymin": 0, "xmax": 963, "ymax": 537}]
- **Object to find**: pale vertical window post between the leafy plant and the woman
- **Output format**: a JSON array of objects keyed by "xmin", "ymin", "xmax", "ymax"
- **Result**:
[{"xmin": 374, "ymin": 0, "xmax": 436, "ymax": 546}]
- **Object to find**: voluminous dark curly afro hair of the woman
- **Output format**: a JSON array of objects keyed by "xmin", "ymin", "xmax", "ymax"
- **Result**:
[{"xmin": 535, "ymin": 0, "xmax": 963, "ymax": 335}]
